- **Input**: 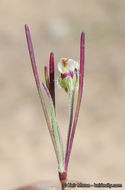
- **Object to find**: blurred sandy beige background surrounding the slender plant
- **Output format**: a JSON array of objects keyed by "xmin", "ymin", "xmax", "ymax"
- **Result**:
[{"xmin": 0, "ymin": 0, "xmax": 125, "ymax": 190}]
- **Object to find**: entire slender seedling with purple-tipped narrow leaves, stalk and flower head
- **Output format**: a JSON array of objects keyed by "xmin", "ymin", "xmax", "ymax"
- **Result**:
[{"xmin": 25, "ymin": 25, "xmax": 85, "ymax": 189}]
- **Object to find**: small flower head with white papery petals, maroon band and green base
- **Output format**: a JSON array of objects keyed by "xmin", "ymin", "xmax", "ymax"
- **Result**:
[{"xmin": 57, "ymin": 58, "xmax": 79, "ymax": 94}]
